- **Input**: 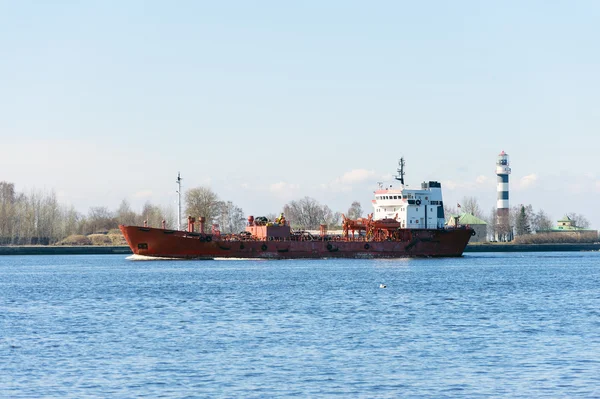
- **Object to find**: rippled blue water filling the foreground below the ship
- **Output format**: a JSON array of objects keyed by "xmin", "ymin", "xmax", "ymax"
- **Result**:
[{"xmin": 0, "ymin": 253, "xmax": 600, "ymax": 398}]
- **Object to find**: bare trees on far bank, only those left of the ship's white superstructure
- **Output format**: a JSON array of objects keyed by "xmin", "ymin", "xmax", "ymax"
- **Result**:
[{"xmin": 0, "ymin": 181, "xmax": 362, "ymax": 245}]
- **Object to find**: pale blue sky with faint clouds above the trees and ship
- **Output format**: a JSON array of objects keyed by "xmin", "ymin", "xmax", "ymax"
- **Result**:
[{"xmin": 0, "ymin": 0, "xmax": 600, "ymax": 228}]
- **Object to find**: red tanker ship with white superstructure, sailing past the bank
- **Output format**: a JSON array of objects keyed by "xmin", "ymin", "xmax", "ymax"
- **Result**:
[{"xmin": 119, "ymin": 159, "xmax": 475, "ymax": 259}]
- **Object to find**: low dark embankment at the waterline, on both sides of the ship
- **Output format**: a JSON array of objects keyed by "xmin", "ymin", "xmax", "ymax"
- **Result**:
[{"xmin": 0, "ymin": 243, "xmax": 600, "ymax": 256}]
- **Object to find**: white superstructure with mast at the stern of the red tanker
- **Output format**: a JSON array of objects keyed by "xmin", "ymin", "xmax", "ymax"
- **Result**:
[{"xmin": 372, "ymin": 160, "xmax": 445, "ymax": 229}]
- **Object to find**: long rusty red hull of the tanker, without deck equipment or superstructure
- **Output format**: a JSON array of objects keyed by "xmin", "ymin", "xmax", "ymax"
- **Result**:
[{"xmin": 119, "ymin": 225, "xmax": 473, "ymax": 259}]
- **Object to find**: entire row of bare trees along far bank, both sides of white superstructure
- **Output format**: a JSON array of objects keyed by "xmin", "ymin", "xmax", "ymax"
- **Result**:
[{"xmin": 0, "ymin": 181, "xmax": 590, "ymax": 245}]
